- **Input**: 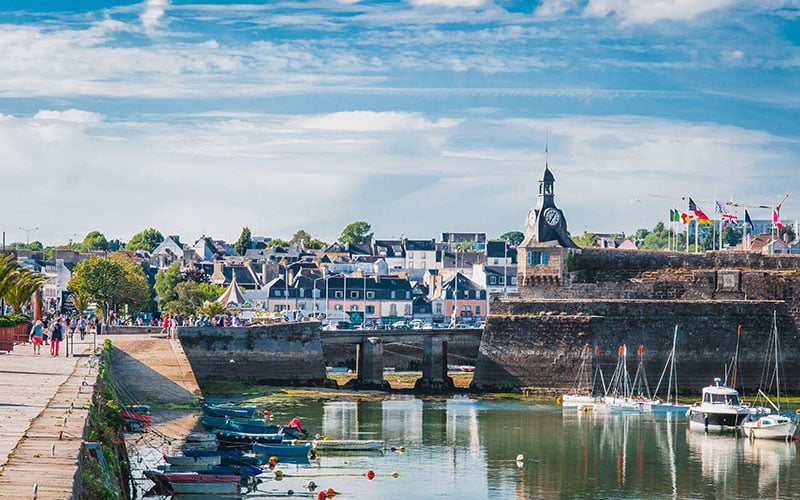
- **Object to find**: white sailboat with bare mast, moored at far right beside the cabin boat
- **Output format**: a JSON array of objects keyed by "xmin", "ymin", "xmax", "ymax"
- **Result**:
[{"xmin": 742, "ymin": 311, "xmax": 797, "ymax": 440}]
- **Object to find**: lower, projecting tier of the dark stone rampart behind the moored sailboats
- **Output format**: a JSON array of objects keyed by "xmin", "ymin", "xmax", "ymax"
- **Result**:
[{"xmin": 472, "ymin": 294, "xmax": 800, "ymax": 395}]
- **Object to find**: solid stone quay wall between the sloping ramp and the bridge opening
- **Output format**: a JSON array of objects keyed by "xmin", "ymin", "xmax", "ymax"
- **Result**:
[{"xmin": 178, "ymin": 322, "xmax": 327, "ymax": 386}]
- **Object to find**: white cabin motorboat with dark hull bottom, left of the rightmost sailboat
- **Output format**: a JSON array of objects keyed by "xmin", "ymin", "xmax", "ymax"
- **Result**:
[{"xmin": 686, "ymin": 377, "xmax": 750, "ymax": 431}]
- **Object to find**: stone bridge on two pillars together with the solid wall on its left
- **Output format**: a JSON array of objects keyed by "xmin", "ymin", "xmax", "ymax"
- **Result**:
[{"xmin": 166, "ymin": 322, "xmax": 483, "ymax": 392}]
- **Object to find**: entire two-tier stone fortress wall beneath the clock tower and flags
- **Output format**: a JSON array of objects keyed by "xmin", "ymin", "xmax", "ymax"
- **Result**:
[{"xmin": 472, "ymin": 247, "xmax": 800, "ymax": 395}]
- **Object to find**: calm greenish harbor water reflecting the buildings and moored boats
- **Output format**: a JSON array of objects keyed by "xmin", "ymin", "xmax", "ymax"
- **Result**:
[{"xmin": 134, "ymin": 396, "xmax": 800, "ymax": 499}]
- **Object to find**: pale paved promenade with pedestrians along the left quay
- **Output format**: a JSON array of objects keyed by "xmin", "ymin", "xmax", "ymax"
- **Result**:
[{"xmin": 0, "ymin": 337, "xmax": 97, "ymax": 499}]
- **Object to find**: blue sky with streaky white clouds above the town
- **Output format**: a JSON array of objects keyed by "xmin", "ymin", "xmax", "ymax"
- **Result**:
[{"xmin": 0, "ymin": 0, "xmax": 800, "ymax": 245}]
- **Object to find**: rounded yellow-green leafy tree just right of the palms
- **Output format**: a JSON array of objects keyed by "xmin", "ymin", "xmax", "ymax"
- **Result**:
[{"xmin": 67, "ymin": 257, "xmax": 125, "ymax": 324}]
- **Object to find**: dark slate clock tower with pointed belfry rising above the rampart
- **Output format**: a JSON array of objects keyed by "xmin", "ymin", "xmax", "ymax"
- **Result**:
[{"xmin": 522, "ymin": 162, "xmax": 578, "ymax": 248}]
